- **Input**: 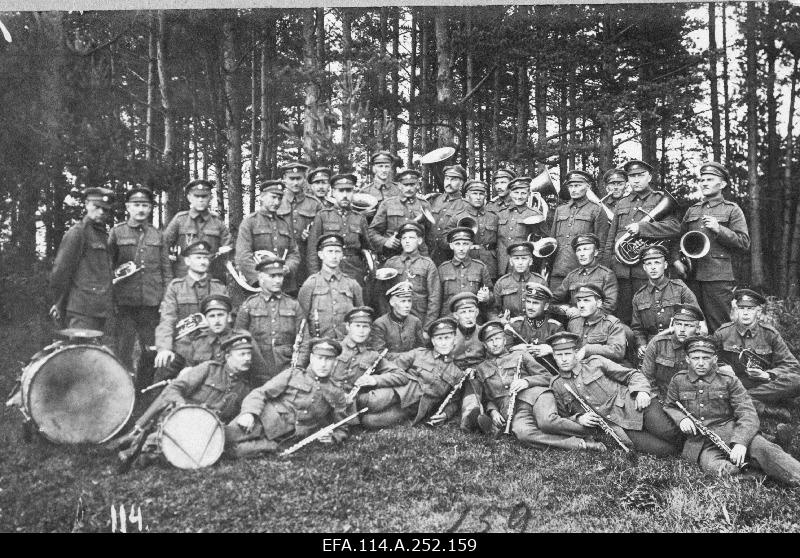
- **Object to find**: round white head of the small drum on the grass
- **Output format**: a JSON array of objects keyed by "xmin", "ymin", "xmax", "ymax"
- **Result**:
[{"xmin": 159, "ymin": 405, "xmax": 225, "ymax": 469}]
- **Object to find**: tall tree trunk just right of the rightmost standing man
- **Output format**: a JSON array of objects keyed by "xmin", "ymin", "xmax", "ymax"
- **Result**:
[{"xmin": 745, "ymin": 3, "xmax": 764, "ymax": 287}]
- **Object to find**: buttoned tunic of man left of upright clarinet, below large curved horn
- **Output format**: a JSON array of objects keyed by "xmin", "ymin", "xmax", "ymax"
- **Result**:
[{"xmin": 235, "ymin": 292, "xmax": 303, "ymax": 378}]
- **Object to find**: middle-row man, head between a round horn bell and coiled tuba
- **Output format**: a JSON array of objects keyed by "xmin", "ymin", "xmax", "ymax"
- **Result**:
[{"xmin": 551, "ymin": 233, "xmax": 618, "ymax": 318}]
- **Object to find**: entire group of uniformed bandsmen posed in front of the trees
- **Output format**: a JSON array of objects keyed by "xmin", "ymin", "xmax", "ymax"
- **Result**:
[{"xmin": 51, "ymin": 151, "xmax": 800, "ymax": 484}]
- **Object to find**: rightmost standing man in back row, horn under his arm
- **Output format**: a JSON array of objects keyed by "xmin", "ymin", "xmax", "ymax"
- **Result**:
[{"xmin": 673, "ymin": 162, "xmax": 750, "ymax": 332}]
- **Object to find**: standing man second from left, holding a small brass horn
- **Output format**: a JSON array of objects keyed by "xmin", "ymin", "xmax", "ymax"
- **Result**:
[{"xmin": 108, "ymin": 188, "xmax": 172, "ymax": 389}]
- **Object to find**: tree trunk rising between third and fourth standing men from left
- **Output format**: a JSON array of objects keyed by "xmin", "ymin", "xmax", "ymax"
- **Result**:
[{"xmin": 222, "ymin": 17, "xmax": 244, "ymax": 231}]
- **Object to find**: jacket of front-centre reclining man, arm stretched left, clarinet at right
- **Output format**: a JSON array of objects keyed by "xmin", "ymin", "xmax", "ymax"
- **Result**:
[{"xmin": 375, "ymin": 347, "xmax": 466, "ymax": 424}]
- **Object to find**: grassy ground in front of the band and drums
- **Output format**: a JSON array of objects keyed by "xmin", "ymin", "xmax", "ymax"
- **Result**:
[{"xmin": 0, "ymin": 320, "xmax": 800, "ymax": 532}]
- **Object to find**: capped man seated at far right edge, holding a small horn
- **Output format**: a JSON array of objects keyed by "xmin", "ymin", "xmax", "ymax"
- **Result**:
[{"xmin": 714, "ymin": 289, "xmax": 800, "ymax": 422}]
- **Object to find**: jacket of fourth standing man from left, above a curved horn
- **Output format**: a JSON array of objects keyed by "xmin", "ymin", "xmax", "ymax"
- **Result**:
[{"xmin": 236, "ymin": 210, "xmax": 300, "ymax": 286}]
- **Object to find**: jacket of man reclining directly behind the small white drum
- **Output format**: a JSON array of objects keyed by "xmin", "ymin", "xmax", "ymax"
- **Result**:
[{"xmin": 161, "ymin": 360, "xmax": 251, "ymax": 422}]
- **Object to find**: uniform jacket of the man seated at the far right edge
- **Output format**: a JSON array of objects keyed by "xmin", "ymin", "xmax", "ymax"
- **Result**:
[{"xmin": 714, "ymin": 322, "xmax": 800, "ymax": 375}]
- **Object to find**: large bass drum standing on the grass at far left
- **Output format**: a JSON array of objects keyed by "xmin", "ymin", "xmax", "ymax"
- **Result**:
[{"xmin": 21, "ymin": 345, "xmax": 136, "ymax": 444}]
